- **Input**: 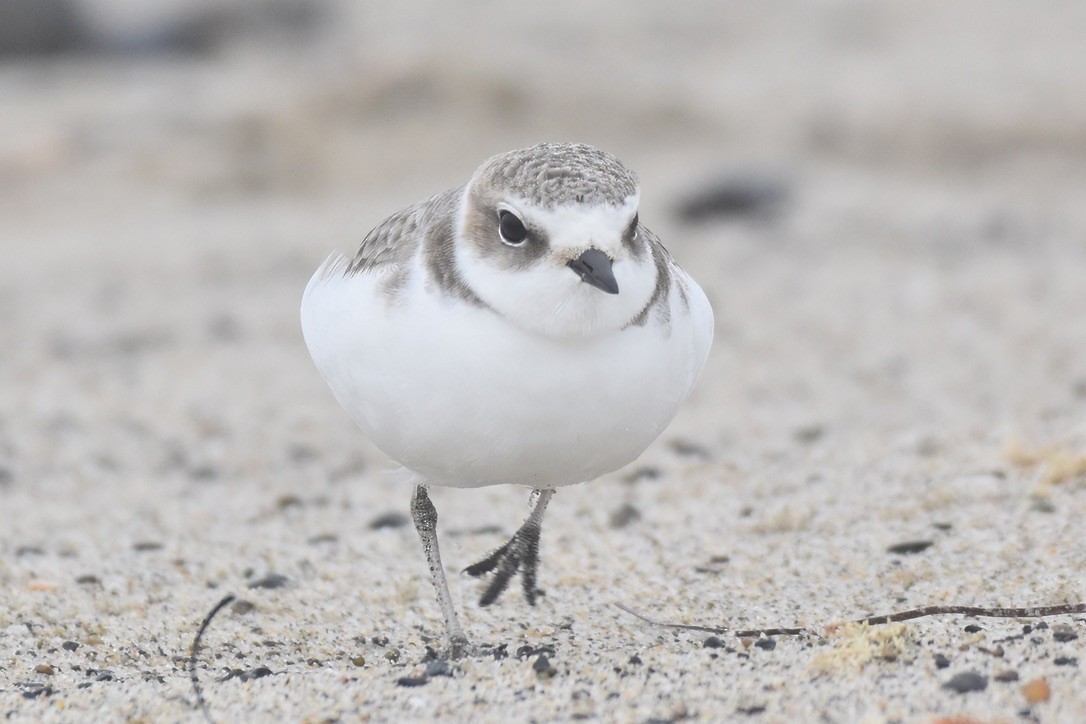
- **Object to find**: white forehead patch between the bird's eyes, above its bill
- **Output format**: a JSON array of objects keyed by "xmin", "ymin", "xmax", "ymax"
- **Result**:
[{"xmin": 512, "ymin": 193, "xmax": 641, "ymax": 254}]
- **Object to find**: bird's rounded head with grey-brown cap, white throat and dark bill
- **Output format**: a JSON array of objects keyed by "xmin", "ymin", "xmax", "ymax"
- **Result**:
[{"xmin": 456, "ymin": 143, "xmax": 657, "ymax": 336}]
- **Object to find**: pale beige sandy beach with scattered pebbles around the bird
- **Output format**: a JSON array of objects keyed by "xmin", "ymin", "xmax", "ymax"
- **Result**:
[{"xmin": 0, "ymin": 0, "xmax": 1086, "ymax": 722}]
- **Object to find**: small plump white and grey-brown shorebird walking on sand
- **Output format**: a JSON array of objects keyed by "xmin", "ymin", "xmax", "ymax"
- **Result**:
[{"xmin": 301, "ymin": 142, "xmax": 714, "ymax": 657}]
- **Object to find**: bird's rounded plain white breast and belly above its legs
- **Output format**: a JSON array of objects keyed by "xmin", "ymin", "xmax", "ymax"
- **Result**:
[{"xmin": 302, "ymin": 257, "xmax": 711, "ymax": 487}]
